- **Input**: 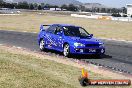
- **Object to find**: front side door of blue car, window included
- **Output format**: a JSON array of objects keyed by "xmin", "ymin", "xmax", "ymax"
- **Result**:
[{"xmin": 53, "ymin": 26, "xmax": 64, "ymax": 51}]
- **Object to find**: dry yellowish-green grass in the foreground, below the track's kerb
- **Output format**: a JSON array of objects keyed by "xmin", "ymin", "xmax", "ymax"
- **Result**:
[{"xmin": 0, "ymin": 49, "xmax": 131, "ymax": 88}]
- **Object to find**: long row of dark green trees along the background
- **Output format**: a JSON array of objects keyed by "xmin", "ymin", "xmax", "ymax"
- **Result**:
[{"xmin": 0, "ymin": 0, "xmax": 127, "ymax": 13}]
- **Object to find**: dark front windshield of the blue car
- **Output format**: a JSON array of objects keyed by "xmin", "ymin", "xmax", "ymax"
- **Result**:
[{"xmin": 63, "ymin": 26, "xmax": 90, "ymax": 38}]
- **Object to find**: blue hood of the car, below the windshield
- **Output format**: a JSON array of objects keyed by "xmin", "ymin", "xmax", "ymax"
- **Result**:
[{"xmin": 69, "ymin": 37, "xmax": 102, "ymax": 44}]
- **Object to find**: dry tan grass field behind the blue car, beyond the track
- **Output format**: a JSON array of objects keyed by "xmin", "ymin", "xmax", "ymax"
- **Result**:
[{"xmin": 0, "ymin": 12, "xmax": 132, "ymax": 40}]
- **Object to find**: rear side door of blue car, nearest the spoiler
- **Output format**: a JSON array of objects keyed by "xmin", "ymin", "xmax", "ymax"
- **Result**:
[{"xmin": 45, "ymin": 25, "xmax": 56, "ymax": 49}]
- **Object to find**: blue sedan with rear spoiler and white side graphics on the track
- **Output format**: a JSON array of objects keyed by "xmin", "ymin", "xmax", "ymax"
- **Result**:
[{"xmin": 38, "ymin": 24, "xmax": 105, "ymax": 57}]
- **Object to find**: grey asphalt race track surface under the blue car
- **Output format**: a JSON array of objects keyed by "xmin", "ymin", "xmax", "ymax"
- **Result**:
[{"xmin": 0, "ymin": 30, "xmax": 132, "ymax": 74}]
